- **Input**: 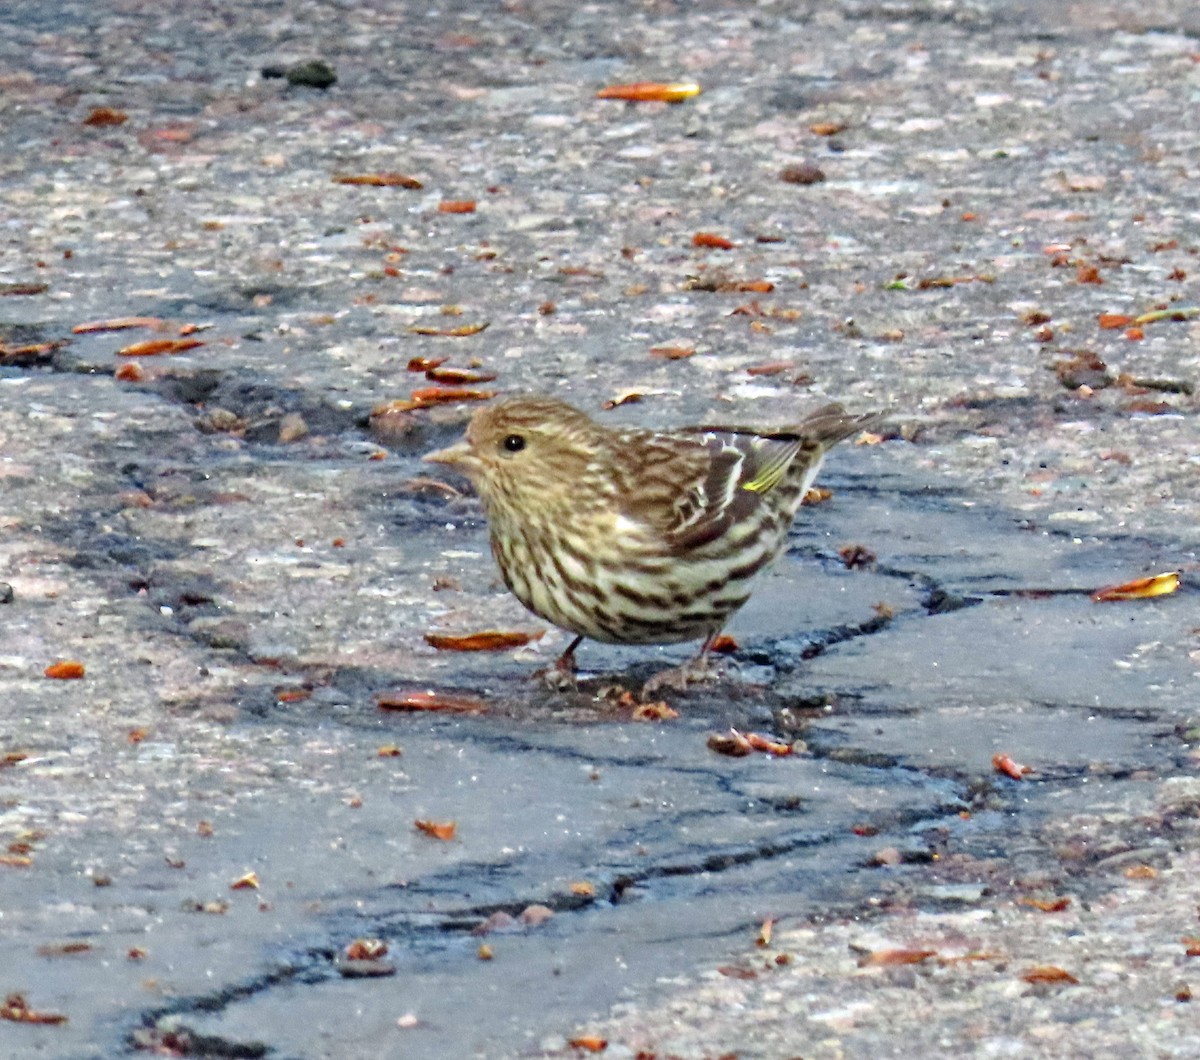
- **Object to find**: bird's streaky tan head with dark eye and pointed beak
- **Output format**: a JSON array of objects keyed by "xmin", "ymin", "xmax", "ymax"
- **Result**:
[{"xmin": 425, "ymin": 397, "xmax": 605, "ymax": 510}]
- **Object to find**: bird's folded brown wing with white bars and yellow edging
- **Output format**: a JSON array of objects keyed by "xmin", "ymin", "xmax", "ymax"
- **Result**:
[{"xmin": 620, "ymin": 427, "xmax": 805, "ymax": 552}]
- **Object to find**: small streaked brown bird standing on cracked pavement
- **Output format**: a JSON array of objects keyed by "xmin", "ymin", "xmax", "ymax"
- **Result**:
[{"xmin": 425, "ymin": 397, "xmax": 877, "ymax": 685}]
